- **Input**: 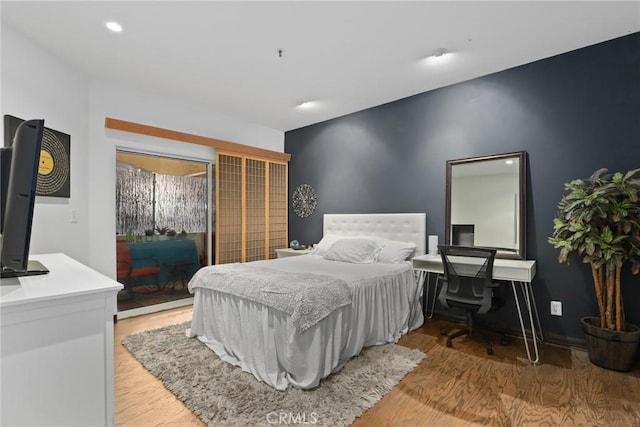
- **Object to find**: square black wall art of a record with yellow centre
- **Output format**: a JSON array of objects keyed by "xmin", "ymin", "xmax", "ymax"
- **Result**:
[{"xmin": 4, "ymin": 115, "xmax": 71, "ymax": 198}]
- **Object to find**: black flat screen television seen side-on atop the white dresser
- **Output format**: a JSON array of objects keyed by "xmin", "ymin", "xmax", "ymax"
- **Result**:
[{"xmin": 0, "ymin": 120, "xmax": 49, "ymax": 278}]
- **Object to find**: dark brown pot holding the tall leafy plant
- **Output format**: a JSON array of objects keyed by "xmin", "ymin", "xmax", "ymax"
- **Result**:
[{"xmin": 582, "ymin": 317, "xmax": 640, "ymax": 372}]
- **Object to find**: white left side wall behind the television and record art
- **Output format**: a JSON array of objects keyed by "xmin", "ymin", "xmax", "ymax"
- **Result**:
[{"xmin": 1, "ymin": 25, "xmax": 90, "ymax": 263}]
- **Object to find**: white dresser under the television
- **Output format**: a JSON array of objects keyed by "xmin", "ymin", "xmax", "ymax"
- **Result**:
[{"xmin": 0, "ymin": 254, "xmax": 122, "ymax": 426}]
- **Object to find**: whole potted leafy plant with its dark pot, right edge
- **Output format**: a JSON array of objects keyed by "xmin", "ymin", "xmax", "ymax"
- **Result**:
[{"xmin": 548, "ymin": 169, "xmax": 640, "ymax": 371}]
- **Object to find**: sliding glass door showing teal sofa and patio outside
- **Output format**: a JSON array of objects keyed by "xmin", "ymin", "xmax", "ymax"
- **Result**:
[{"xmin": 116, "ymin": 151, "xmax": 213, "ymax": 312}]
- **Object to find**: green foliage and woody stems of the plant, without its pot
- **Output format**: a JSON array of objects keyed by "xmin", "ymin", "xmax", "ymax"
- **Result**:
[{"xmin": 548, "ymin": 168, "xmax": 640, "ymax": 331}]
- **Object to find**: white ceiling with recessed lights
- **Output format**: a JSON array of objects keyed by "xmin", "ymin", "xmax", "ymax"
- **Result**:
[{"xmin": 1, "ymin": 0, "xmax": 640, "ymax": 131}]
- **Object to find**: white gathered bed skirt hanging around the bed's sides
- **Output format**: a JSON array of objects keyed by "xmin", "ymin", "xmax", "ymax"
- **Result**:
[{"xmin": 189, "ymin": 268, "xmax": 424, "ymax": 390}]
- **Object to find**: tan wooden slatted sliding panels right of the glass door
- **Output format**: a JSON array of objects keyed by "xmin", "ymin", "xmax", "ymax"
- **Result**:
[{"xmin": 215, "ymin": 152, "xmax": 287, "ymax": 264}]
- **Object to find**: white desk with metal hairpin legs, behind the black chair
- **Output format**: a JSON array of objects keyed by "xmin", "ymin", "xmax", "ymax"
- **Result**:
[{"xmin": 412, "ymin": 255, "xmax": 543, "ymax": 364}]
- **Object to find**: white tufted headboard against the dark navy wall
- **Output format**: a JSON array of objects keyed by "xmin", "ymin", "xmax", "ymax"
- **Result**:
[{"xmin": 323, "ymin": 213, "xmax": 427, "ymax": 255}]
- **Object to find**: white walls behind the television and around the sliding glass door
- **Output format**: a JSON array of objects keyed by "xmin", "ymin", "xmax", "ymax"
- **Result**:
[{"xmin": 1, "ymin": 26, "xmax": 284, "ymax": 277}]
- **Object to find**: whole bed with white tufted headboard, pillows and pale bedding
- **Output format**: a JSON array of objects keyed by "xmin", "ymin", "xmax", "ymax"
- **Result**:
[{"xmin": 188, "ymin": 213, "xmax": 426, "ymax": 390}]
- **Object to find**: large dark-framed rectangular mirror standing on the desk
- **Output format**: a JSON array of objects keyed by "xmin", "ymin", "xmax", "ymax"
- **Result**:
[{"xmin": 445, "ymin": 151, "xmax": 527, "ymax": 259}]
